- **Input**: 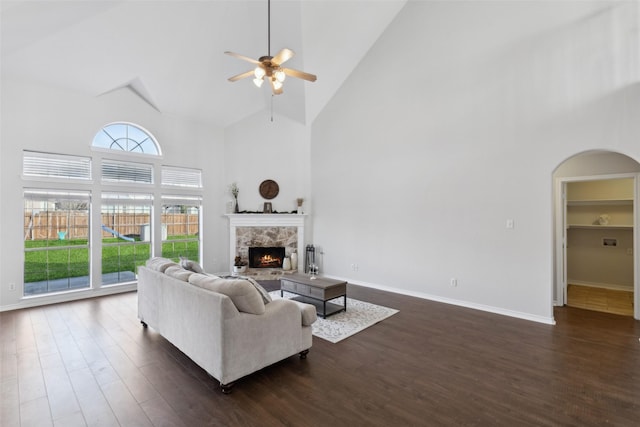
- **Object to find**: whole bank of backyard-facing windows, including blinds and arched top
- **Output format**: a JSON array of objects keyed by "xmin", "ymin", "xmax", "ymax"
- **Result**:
[{"xmin": 22, "ymin": 123, "xmax": 203, "ymax": 297}]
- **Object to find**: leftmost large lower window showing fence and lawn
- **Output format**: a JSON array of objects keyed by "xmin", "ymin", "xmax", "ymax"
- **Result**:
[{"xmin": 24, "ymin": 190, "xmax": 91, "ymax": 296}]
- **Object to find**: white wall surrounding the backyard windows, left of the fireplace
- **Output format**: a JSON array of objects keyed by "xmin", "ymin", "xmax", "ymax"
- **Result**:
[{"xmin": 0, "ymin": 77, "xmax": 227, "ymax": 309}]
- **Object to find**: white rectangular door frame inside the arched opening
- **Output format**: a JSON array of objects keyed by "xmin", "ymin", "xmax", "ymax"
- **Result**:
[{"xmin": 554, "ymin": 173, "xmax": 640, "ymax": 320}]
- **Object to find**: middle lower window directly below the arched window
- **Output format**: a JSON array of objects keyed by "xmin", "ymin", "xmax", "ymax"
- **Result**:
[{"xmin": 100, "ymin": 193, "xmax": 153, "ymax": 285}]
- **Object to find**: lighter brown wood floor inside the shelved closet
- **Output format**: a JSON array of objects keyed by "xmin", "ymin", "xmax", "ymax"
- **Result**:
[{"xmin": 567, "ymin": 284, "xmax": 633, "ymax": 316}]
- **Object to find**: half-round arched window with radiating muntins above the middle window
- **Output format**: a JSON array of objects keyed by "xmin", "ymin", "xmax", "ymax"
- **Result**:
[{"xmin": 92, "ymin": 123, "xmax": 161, "ymax": 156}]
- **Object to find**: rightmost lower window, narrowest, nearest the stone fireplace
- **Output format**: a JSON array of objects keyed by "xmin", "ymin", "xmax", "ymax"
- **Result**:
[{"xmin": 161, "ymin": 195, "xmax": 202, "ymax": 262}]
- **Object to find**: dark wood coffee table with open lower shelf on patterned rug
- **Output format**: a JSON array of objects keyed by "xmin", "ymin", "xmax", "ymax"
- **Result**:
[{"xmin": 280, "ymin": 274, "xmax": 347, "ymax": 319}]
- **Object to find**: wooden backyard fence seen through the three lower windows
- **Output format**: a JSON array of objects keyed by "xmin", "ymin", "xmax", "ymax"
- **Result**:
[{"xmin": 24, "ymin": 211, "xmax": 199, "ymax": 240}]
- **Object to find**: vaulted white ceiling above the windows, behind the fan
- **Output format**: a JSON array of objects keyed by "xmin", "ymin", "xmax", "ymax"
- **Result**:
[{"xmin": 0, "ymin": 0, "xmax": 406, "ymax": 127}]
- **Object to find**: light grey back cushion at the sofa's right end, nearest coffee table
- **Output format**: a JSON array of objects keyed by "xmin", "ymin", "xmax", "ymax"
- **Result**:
[{"xmin": 189, "ymin": 273, "xmax": 264, "ymax": 314}]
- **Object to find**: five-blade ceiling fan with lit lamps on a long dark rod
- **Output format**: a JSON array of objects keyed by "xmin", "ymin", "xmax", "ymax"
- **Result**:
[{"xmin": 225, "ymin": 0, "xmax": 317, "ymax": 95}]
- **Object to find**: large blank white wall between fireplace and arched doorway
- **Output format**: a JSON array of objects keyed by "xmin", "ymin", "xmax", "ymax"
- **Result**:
[{"xmin": 311, "ymin": 1, "xmax": 640, "ymax": 322}]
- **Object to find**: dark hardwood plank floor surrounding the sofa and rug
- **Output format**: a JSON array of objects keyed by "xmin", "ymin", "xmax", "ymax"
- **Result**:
[{"xmin": 0, "ymin": 285, "xmax": 640, "ymax": 427}]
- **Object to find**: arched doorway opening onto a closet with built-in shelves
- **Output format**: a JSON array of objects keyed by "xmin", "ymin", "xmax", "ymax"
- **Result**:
[{"xmin": 553, "ymin": 150, "xmax": 640, "ymax": 319}]
